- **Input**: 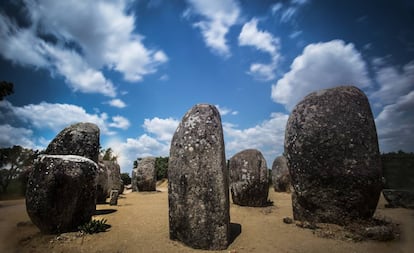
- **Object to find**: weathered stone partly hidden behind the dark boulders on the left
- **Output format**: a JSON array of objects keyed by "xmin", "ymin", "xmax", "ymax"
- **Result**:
[{"xmin": 96, "ymin": 159, "xmax": 123, "ymax": 203}]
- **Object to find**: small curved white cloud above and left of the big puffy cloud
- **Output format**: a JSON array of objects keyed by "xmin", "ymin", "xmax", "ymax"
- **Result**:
[{"xmin": 239, "ymin": 18, "xmax": 280, "ymax": 81}]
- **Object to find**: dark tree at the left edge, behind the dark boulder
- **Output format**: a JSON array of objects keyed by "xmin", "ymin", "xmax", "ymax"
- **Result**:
[{"xmin": 0, "ymin": 146, "xmax": 37, "ymax": 193}]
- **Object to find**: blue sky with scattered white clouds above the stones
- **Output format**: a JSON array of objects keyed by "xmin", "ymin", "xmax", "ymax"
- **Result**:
[{"xmin": 0, "ymin": 0, "xmax": 414, "ymax": 172}]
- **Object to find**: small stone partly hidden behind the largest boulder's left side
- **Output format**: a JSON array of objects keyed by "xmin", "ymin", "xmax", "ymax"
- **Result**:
[{"xmin": 272, "ymin": 155, "xmax": 291, "ymax": 192}]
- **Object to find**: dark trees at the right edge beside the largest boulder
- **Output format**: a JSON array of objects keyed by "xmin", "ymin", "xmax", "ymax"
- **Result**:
[{"xmin": 381, "ymin": 150, "xmax": 414, "ymax": 191}]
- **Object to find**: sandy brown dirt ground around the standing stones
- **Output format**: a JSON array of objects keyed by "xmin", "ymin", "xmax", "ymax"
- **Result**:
[{"xmin": 0, "ymin": 183, "xmax": 414, "ymax": 253}]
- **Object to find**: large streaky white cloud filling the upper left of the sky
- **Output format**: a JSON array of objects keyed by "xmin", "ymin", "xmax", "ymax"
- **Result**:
[{"xmin": 0, "ymin": 0, "xmax": 168, "ymax": 97}]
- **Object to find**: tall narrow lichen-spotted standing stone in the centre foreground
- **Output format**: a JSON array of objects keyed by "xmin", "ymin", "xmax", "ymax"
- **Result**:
[{"xmin": 168, "ymin": 104, "xmax": 230, "ymax": 250}]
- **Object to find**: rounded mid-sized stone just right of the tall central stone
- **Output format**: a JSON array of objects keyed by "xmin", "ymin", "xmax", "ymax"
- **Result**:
[{"xmin": 229, "ymin": 149, "xmax": 269, "ymax": 207}]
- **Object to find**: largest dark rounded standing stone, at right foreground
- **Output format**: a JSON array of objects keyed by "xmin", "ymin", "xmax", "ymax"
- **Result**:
[{"xmin": 285, "ymin": 86, "xmax": 382, "ymax": 224}]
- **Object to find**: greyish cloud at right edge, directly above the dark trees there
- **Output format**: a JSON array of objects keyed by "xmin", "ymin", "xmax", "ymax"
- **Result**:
[{"xmin": 375, "ymin": 91, "xmax": 414, "ymax": 152}]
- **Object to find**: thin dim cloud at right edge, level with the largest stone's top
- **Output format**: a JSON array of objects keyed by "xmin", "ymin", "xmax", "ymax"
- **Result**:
[{"xmin": 370, "ymin": 59, "xmax": 414, "ymax": 105}]
